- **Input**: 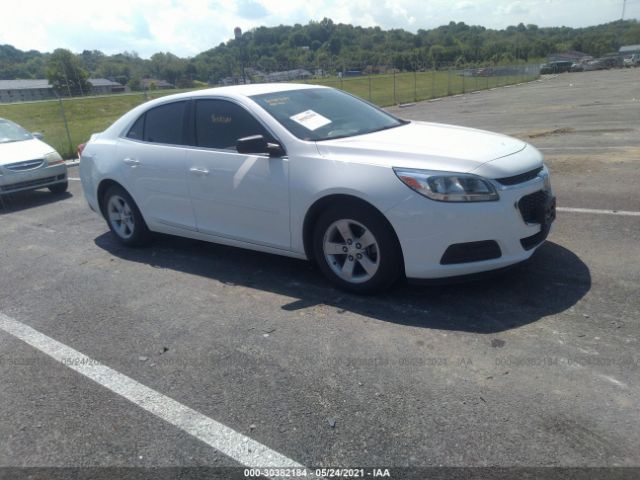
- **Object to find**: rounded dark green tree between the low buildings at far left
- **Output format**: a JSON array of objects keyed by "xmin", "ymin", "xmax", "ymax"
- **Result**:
[{"xmin": 46, "ymin": 48, "xmax": 91, "ymax": 96}]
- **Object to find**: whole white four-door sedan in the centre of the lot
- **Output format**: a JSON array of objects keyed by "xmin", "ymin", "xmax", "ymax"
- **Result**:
[{"xmin": 80, "ymin": 84, "xmax": 555, "ymax": 293}]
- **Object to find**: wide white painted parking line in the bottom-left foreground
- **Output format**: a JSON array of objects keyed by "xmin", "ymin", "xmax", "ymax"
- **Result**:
[{"xmin": 0, "ymin": 313, "xmax": 311, "ymax": 478}]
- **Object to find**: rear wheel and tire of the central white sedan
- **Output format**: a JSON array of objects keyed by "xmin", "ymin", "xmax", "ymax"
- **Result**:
[{"xmin": 102, "ymin": 185, "xmax": 151, "ymax": 247}]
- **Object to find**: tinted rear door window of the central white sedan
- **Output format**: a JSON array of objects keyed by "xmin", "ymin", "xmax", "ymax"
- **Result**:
[{"xmin": 127, "ymin": 102, "xmax": 187, "ymax": 145}]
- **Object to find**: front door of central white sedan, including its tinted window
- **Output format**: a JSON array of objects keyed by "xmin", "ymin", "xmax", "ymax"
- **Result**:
[{"xmin": 186, "ymin": 99, "xmax": 291, "ymax": 249}]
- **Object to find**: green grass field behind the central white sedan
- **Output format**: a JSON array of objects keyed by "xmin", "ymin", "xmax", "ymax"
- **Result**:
[{"xmin": 0, "ymin": 71, "xmax": 536, "ymax": 158}]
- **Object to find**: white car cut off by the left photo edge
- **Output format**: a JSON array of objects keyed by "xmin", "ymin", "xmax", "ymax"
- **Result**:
[{"xmin": 0, "ymin": 118, "xmax": 68, "ymax": 195}]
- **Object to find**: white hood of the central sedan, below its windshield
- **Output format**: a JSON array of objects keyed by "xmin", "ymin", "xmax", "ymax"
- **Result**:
[{"xmin": 316, "ymin": 122, "xmax": 542, "ymax": 178}]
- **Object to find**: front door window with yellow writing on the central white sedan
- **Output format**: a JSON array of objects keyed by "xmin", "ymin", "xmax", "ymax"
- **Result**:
[{"xmin": 195, "ymin": 99, "xmax": 270, "ymax": 149}]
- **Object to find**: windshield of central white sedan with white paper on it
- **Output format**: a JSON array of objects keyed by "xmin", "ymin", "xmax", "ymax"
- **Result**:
[{"xmin": 251, "ymin": 88, "xmax": 407, "ymax": 141}]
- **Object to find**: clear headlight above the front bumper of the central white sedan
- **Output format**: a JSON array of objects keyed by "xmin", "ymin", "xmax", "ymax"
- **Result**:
[{"xmin": 393, "ymin": 168, "xmax": 500, "ymax": 202}]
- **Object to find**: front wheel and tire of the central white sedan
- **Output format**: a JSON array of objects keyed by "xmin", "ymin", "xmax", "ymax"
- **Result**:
[{"xmin": 313, "ymin": 204, "xmax": 403, "ymax": 294}]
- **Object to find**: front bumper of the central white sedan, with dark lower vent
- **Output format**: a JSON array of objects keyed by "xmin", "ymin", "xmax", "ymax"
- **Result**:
[{"xmin": 385, "ymin": 178, "xmax": 555, "ymax": 279}]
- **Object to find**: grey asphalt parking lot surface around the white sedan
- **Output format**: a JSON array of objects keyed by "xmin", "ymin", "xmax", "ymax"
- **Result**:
[{"xmin": 0, "ymin": 68, "xmax": 640, "ymax": 478}]
